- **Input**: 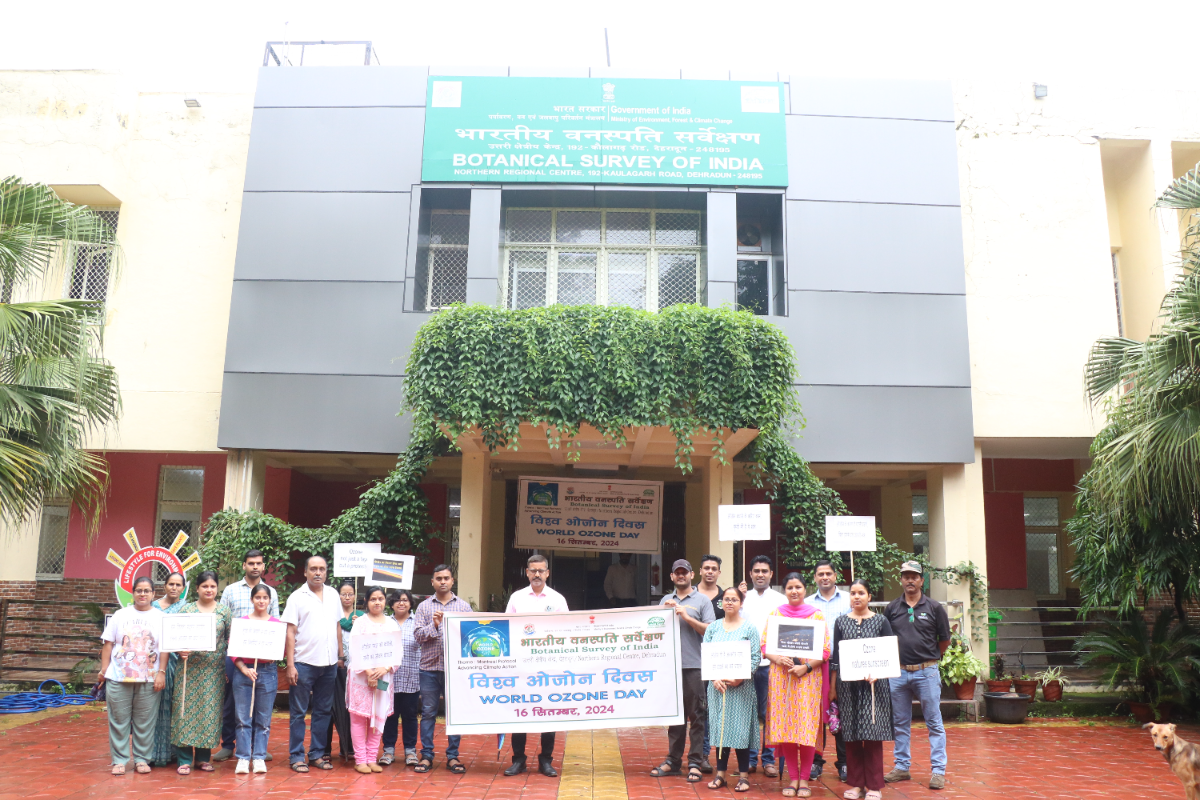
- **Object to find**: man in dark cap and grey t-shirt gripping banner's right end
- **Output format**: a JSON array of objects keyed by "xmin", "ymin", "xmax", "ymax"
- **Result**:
[{"xmin": 650, "ymin": 559, "xmax": 716, "ymax": 783}]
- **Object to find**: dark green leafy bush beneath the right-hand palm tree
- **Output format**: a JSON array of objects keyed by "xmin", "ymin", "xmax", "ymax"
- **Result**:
[{"xmin": 1075, "ymin": 607, "xmax": 1200, "ymax": 723}]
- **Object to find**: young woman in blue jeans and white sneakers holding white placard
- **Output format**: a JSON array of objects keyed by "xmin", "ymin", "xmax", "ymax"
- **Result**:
[{"xmin": 233, "ymin": 582, "xmax": 283, "ymax": 775}]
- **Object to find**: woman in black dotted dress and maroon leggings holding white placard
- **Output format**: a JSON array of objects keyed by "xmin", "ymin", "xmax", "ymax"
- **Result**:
[{"xmin": 829, "ymin": 579, "xmax": 893, "ymax": 800}]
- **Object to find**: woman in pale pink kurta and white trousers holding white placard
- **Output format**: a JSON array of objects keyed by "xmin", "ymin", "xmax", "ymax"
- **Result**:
[{"xmin": 346, "ymin": 587, "xmax": 398, "ymax": 774}]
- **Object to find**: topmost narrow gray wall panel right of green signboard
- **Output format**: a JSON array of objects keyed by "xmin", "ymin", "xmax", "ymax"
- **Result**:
[{"xmin": 791, "ymin": 77, "xmax": 954, "ymax": 122}]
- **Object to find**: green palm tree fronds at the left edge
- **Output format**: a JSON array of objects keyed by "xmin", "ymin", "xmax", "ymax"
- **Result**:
[{"xmin": 0, "ymin": 178, "xmax": 120, "ymax": 533}]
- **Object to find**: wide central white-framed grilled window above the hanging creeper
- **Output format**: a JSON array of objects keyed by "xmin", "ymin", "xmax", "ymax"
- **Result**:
[{"xmin": 504, "ymin": 209, "xmax": 703, "ymax": 311}]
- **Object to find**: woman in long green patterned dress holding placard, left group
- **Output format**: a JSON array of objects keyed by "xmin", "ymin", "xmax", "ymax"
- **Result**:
[{"xmin": 170, "ymin": 570, "xmax": 233, "ymax": 775}]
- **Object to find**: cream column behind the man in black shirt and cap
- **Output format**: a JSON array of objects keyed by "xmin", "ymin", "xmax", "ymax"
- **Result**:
[{"xmin": 925, "ymin": 444, "xmax": 988, "ymax": 658}]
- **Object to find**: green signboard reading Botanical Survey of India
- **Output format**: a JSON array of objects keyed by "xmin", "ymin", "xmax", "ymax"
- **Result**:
[{"xmin": 421, "ymin": 77, "xmax": 787, "ymax": 186}]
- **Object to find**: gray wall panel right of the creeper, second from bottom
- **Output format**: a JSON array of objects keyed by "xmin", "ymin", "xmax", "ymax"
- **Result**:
[{"xmin": 774, "ymin": 291, "xmax": 971, "ymax": 386}]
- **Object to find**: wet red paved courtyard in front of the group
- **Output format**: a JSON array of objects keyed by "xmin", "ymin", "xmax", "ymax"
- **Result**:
[{"xmin": 0, "ymin": 709, "xmax": 1185, "ymax": 800}]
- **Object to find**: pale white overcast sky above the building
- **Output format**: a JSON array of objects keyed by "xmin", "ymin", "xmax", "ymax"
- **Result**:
[{"xmin": 0, "ymin": 0, "xmax": 1196, "ymax": 92}]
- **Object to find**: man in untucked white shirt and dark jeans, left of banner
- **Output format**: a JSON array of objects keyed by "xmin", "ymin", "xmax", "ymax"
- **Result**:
[{"xmin": 282, "ymin": 555, "xmax": 342, "ymax": 772}]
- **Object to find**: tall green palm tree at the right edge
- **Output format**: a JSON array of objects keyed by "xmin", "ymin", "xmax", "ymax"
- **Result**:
[{"xmin": 1067, "ymin": 168, "xmax": 1200, "ymax": 622}]
